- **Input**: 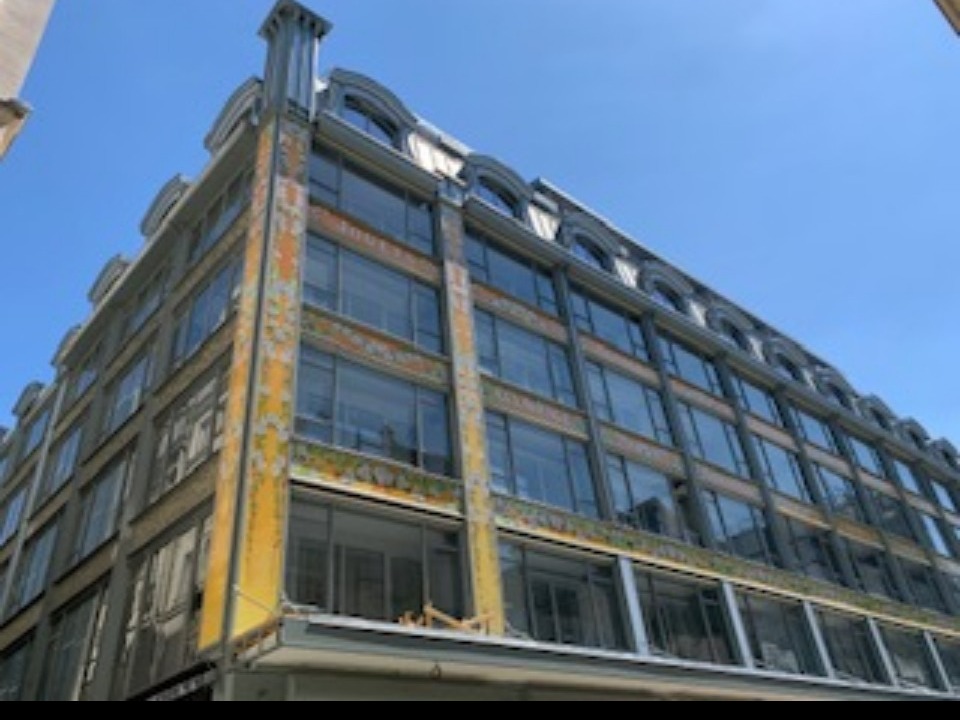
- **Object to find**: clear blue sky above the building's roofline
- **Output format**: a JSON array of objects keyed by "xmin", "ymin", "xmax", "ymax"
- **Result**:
[{"xmin": 0, "ymin": 0, "xmax": 960, "ymax": 442}]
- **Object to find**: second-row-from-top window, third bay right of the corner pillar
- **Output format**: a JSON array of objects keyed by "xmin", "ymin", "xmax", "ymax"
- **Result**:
[{"xmin": 587, "ymin": 362, "xmax": 674, "ymax": 445}]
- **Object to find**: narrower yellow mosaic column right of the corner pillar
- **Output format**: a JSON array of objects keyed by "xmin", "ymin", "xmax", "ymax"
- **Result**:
[{"xmin": 440, "ymin": 202, "xmax": 506, "ymax": 635}]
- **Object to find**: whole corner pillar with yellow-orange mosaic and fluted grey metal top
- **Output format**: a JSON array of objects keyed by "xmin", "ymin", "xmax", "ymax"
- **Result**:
[{"xmin": 199, "ymin": 0, "xmax": 330, "ymax": 653}]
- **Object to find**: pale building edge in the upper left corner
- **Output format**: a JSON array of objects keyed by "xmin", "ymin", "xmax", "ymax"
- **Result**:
[{"xmin": 0, "ymin": 0, "xmax": 54, "ymax": 159}]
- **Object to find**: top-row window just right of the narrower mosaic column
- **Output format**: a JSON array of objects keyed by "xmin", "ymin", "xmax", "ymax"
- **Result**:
[{"xmin": 466, "ymin": 232, "xmax": 559, "ymax": 315}]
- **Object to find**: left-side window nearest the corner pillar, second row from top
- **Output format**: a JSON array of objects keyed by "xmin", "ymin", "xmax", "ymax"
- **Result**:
[{"xmin": 173, "ymin": 260, "xmax": 241, "ymax": 366}]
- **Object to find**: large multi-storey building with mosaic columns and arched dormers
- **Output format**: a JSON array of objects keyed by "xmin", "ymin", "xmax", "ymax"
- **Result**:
[{"xmin": 0, "ymin": 0, "xmax": 960, "ymax": 700}]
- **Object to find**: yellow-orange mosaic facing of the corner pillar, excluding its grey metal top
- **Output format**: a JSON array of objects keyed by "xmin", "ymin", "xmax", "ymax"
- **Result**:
[{"xmin": 199, "ymin": 115, "xmax": 310, "ymax": 650}]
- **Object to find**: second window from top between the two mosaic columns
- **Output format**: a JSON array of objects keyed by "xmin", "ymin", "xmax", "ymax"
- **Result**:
[{"xmin": 304, "ymin": 237, "xmax": 443, "ymax": 353}]
